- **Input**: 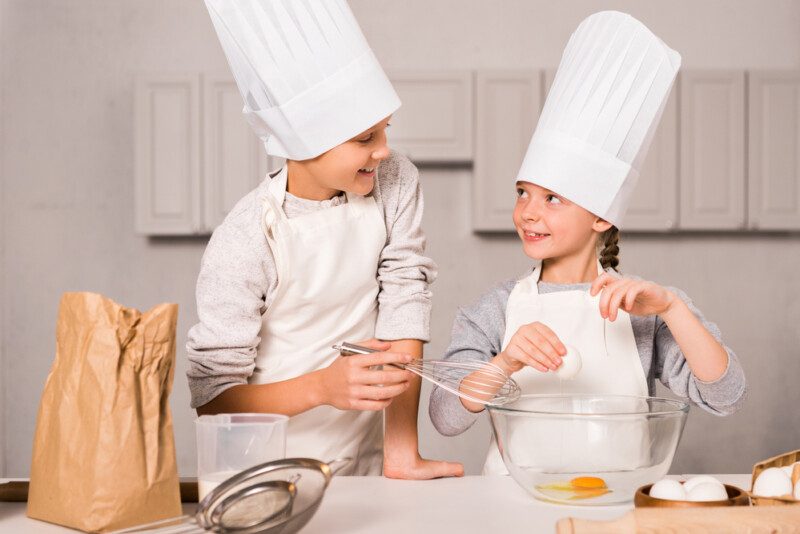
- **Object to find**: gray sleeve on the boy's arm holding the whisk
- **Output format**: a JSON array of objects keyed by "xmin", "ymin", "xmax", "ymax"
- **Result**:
[{"xmin": 186, "ymin": 199, "xmax": 272, "ymax": 408}]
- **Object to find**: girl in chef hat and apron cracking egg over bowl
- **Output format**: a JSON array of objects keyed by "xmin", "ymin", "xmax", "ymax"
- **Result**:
[{"xmin": 430, "ymin": 12, "xmax": 745, "ymax": 474}]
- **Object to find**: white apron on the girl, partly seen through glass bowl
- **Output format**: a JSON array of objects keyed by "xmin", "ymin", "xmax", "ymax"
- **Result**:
[{"xmin": 483, "ymin": 263, "xmax": 649, "ymax": 474}]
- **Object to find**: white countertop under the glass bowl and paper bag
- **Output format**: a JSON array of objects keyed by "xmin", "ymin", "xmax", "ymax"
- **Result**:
[{"xmin": 0, "ymin": 474, "xmax": 750, "ymax": 534}]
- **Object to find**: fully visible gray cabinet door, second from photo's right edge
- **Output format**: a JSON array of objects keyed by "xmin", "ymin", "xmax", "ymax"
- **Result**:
[{"xmin": 680, "ymin": 71, "xmax": 746, "ymax": 230}]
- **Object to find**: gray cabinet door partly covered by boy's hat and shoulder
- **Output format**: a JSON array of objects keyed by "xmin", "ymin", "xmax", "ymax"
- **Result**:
[{"xmin": 203, "ymin": 74, "xmax": 278, "ymax": 233}]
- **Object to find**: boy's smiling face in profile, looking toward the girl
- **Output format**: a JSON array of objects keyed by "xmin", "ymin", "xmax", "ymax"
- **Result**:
[{"xmin": 288, "ymin": 116, "xmax": 391, "ymax": 200}]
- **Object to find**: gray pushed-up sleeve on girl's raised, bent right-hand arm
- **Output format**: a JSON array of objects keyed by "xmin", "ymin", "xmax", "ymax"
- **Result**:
[{"xmin": 654, "ymin": 288, "xmax": 746, "ymax": 415}]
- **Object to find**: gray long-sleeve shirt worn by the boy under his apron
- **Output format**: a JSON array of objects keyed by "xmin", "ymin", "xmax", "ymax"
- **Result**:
[{"xmin": 186, "ymin": 152, "xmax": 436, "ymax": 408}]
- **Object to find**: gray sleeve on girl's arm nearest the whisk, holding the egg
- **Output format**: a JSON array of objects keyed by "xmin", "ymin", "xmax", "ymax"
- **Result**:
[{"xmin": 428, "ymin": 281, "xmax": 515, "ymax": 436}]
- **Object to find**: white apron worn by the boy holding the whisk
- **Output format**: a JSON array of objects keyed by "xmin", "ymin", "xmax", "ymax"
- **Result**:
[{"xmin": 249, "ymin": 167, "xmax": 386, "ymax": 475}]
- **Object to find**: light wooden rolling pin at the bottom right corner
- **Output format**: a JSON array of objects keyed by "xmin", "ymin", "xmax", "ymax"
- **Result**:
[{"xmin": 556, "ymin": 506, "xmax": 800, "ymax": 534}]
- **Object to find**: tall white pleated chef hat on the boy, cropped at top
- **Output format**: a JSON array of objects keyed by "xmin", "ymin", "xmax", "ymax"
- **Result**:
[{"xmin": 205, "ymin": 0, "xmax": 400, "ymax": 160}]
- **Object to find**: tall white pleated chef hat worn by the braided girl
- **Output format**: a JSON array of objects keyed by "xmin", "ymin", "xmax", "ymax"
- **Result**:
[{"xmin": 517, "ymin": 11, "xmax": 681, "ymax": 227}]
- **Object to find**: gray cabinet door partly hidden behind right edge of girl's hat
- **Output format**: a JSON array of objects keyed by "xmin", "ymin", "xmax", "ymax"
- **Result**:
[{"xmin": 623, "ymin": 82, "xmax": 680, "ymax": 232}]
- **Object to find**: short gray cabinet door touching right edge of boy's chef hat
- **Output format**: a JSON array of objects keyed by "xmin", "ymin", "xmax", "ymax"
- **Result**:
[{"xmin": 389, "ymin": 72, "xmax": 473, "ymax": 163}]
